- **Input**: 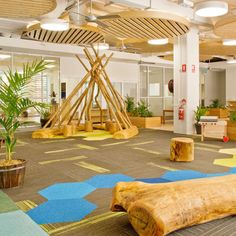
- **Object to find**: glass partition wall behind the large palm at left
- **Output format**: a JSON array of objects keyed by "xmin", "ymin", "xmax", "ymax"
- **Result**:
[{"xmin": 0, "ymin": 52, "xmax": 60, "ymax": 123}]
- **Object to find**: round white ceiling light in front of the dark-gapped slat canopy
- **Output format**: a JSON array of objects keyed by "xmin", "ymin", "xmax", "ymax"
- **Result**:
[{"xmin": 40, "ymin": 19, "xmax": 69, "ymax": 31}]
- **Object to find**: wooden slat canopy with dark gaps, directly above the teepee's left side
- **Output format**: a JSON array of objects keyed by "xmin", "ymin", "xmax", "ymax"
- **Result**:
[{"xmin": 24, "ymin": 28, "xmax": 104, "ymax": 45}]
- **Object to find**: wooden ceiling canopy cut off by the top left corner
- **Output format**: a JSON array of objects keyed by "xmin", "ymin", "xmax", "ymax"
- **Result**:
[{"xmin": 0, "ymin": 0, "xmax": 56, "ymax": 18}]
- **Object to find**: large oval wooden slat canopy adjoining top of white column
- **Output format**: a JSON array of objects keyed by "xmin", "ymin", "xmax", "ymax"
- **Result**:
[{"xmin": 101, "ymin": 11, "xmax": 189, "ymax": 40}]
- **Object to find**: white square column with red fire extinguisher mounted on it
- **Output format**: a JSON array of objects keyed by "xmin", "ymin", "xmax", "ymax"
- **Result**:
[{"xmin": 174, "ymin": 28, "xmax": 200, "ymax": 134}]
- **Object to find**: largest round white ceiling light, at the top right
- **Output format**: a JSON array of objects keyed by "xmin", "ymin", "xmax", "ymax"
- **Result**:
[{"xmin": 194, "ymin": 1, "xmax": 228, "ymax": 17}]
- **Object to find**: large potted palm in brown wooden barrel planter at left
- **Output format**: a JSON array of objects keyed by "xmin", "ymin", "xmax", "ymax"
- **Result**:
[{"xmin": 0, "ymin": 60, "xmax": 46, "ymax": 188}]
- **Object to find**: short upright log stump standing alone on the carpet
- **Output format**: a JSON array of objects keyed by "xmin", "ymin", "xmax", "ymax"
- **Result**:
[{"xmin": 170, "ymin": 137, "xmax": 194, "ymax": 161}]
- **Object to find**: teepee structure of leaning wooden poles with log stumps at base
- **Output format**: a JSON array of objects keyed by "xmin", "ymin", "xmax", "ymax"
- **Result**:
[{"xmin": 33, "ymin": 47, "xmax": 138, "ymax": 139}]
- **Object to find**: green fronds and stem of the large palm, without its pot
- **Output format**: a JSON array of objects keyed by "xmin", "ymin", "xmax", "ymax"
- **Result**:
[{"xmin": 0, "ymin": 60, "xmax": 47, "ymax": 161}]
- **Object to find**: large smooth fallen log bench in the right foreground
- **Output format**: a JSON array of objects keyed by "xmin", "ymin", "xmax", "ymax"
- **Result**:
[{"xmin": 111, "ymin": 175, "xmax": 236, "ymax": 236}]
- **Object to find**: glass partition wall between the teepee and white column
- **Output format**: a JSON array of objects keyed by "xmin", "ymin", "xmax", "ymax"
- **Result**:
[{"xmin": 140, "ymin": 66, "xmax": 174, "ymax": 116}]
